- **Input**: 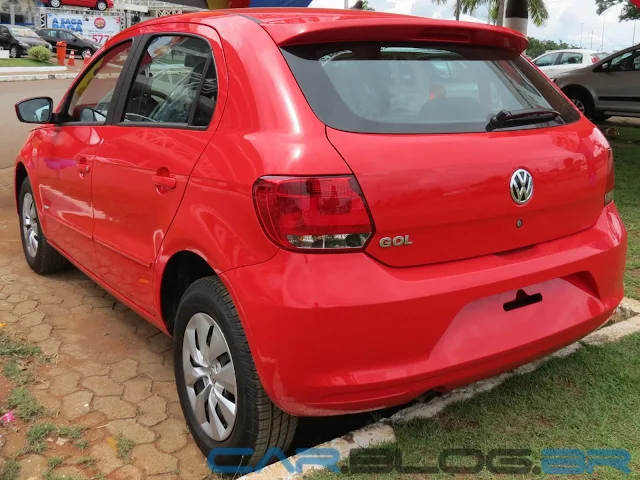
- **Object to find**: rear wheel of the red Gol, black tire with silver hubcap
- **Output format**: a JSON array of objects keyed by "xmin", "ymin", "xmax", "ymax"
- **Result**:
[{"xmin": 173, "ymin": 277, "xmax": 297, "ymax": 466}]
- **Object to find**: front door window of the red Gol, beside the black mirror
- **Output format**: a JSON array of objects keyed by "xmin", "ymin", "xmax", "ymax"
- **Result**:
[{"xmin": 66, "ymin": 41, "xmax": 132, "ymax": 123}]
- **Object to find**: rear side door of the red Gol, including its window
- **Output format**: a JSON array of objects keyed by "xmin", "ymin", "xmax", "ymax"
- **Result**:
[{"xmin": 93, "ymin": 24, "xmax": 223, "ymax": 315}]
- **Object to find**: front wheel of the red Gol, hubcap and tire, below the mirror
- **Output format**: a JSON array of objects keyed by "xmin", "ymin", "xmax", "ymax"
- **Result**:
[{"xmin": 18, "ymin": 178, "xmax": 69, "ymax": 274}]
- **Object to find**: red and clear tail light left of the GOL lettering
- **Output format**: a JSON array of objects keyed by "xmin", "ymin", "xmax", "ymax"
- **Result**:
[{"xmin": 253, "ymin": 176, "xmax": 373, "ymax": 251}]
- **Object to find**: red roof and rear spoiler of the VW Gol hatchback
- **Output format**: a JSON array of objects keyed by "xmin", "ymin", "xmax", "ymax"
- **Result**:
[{"xmin": 110, "ymin": 8, "xmax": 528, "ymax": 53}]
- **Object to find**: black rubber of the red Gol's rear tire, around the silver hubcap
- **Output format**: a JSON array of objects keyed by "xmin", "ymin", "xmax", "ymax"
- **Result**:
[{"xmin": 174, "ymin": 277, "xmax": 298, "ymax": 465}]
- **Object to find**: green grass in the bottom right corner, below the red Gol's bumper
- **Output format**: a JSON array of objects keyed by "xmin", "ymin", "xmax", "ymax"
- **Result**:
[{"xmin": 307, "ymin": 334, "xmax": 640, "ymax": 480}]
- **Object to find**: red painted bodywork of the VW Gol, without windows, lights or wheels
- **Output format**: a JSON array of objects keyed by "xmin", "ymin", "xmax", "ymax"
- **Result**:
[{"xmin": 17, "ymin": 9, "xmax": 627, "ymax": 415}]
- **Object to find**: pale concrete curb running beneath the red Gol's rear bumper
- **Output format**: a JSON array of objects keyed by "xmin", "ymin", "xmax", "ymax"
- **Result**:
[{"xmin": 238, "ymin": 298, "xmax": 640, "ymax": 480}]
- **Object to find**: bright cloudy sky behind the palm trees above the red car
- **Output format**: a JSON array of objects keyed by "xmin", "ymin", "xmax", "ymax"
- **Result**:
[{"xmin": 311, "ymin": 0, "xmax": 640, "ymax": 52}]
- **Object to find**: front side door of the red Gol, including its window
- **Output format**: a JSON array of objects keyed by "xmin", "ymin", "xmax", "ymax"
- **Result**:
[{"xmin": 38, "ymin": 40, "xmax": 132, "ymax": 271}]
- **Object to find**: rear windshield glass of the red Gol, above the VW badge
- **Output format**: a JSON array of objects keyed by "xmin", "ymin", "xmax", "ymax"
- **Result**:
[{"xmin": 282, "ymin": 42, "xmax": 580, "ymax": 133}]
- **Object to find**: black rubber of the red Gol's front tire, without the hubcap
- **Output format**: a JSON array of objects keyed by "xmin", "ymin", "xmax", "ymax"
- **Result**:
[{"xmin": 18, "ymin": 178, "xmax": 69, "ymax": 275}]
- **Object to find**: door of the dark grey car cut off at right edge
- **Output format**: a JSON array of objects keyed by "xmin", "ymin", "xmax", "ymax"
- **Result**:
[{"xmin": 594, "ymin": 48, "xmax": 640, "ymax": 114}]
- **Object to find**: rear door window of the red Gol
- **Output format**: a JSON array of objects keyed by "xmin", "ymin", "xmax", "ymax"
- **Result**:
[{"xmin": 122, "ymin": 35, "xmax": 218, "ymax": 126}]
